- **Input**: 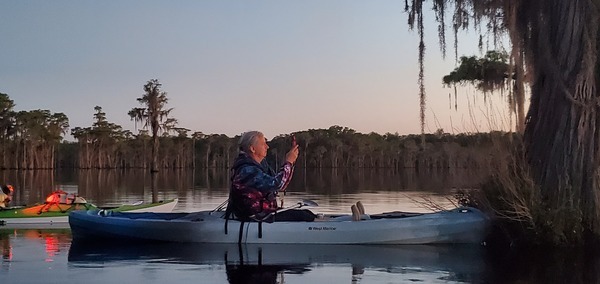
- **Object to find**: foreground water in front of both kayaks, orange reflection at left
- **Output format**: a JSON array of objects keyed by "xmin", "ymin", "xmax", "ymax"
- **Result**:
[{"xmin": 0, "ymin": 229, "xmax": 600, "ymax": 284}]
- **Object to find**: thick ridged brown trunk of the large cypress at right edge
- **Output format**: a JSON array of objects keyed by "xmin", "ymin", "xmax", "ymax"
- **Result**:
[{"xmin": 511, "ymin": 0, "xmax": 600, "ymax": 235}]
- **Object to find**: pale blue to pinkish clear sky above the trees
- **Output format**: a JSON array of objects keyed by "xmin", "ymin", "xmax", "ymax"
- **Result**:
[{"xmin": 0, "ymin": 0, "xmax": 510, "ymax": 140}]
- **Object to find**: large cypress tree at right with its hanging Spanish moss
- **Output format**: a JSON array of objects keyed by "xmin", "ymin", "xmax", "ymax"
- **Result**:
[{"xmin": 406, "ymin": 0, "xmax": 600, "ymax": 245}]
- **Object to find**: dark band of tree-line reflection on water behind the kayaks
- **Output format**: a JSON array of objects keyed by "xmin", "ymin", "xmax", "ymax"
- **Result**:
[{"xmin": 0, "ymin": 168, "xmax": 486, "ymax": 211}]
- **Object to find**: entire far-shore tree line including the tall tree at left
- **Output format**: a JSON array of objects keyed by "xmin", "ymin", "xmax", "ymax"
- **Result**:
[{"xmin": 0, "ymin": 80, "xmax": 513, "ymax": 171}]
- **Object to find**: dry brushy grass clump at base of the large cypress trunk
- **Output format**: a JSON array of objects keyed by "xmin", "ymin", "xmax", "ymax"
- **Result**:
[{"xmin": 455, "ymin": 140, "xmax": 585, "ymax": 246}]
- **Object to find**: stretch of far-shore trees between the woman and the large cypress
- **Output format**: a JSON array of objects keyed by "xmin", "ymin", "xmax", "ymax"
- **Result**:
[{"xmin": 268, "ymin": 125, "xmax": 510, "ymax": 169}]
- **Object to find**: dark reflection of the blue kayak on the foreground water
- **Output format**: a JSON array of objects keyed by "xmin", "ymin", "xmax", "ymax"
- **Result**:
[{"xmin": 68, "ymin": 239, "xmax": 485, "ymax": 283}]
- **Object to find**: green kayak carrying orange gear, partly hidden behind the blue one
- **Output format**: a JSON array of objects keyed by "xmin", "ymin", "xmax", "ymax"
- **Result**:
[{"xmin": 0, "ymin": 199, "xmax": 178, "ymax": 229}]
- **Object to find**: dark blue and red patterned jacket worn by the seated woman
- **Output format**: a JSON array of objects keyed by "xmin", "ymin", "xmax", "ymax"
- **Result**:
[{"xmin": 229, "ymin": 152, "xmax": 293, "ymax": 220}]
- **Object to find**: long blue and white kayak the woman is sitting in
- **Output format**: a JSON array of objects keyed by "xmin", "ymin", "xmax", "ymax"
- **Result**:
[{"xmin": 69, "ymin": 204, "xmax": 489, "ymax": 244}]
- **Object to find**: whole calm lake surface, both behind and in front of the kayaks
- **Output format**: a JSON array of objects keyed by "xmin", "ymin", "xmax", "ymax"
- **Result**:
[{"xmin": 0, "ymin": 169, "xmax": 600, "ymax": 284}]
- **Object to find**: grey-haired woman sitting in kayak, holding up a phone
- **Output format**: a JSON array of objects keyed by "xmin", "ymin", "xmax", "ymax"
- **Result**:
[{"xmin": 228, "ymin": 131, "xmax": 315, "ymax": 222}]
